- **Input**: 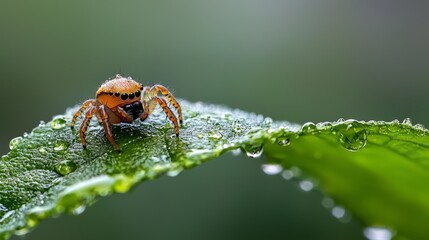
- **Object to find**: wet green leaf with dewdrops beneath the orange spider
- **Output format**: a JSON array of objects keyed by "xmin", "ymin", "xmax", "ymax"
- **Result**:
[{"xmin": 0, "ymin": 100, "xmax": 429, "ymax": 239}]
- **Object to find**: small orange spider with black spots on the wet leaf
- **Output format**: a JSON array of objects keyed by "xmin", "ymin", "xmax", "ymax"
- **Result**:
[{"xmin": 71, "ymin": 74, "xmax": 183, "ymax": 152}]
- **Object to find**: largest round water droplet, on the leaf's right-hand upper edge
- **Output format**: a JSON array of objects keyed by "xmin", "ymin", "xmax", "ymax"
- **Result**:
[{"xmin": 338, "ymin": 124, "xmax": 367, "ymax": 152}]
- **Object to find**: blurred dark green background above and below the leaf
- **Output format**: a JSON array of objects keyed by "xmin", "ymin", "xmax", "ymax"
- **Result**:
[{"xmin": 0, "ymin": 0, "xmax": 429, "ymax": 239}]
